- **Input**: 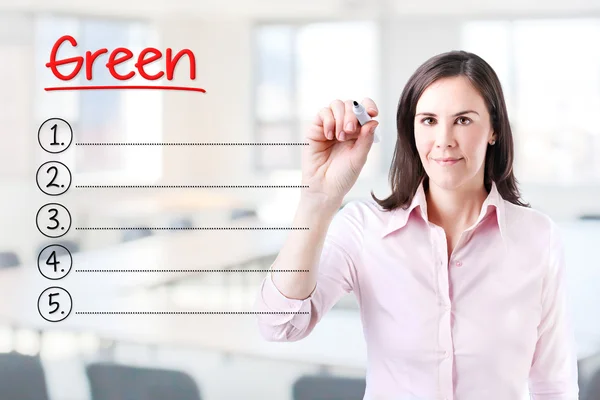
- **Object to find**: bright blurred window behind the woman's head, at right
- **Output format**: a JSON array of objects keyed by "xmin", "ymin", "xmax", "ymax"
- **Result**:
[{"xmin": 463, "ymin": 19, "xmax": 600, "ymax": 184}]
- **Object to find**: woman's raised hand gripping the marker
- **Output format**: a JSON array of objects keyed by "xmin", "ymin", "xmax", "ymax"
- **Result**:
[{"xmin": 302, "ymin": 98, "xmax": 379, "ymax": 203}]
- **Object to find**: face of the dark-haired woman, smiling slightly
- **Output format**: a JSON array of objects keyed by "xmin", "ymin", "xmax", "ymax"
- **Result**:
[{"xmin": 414, "ymin": 76, "xmax": 496, "ymax": 190}]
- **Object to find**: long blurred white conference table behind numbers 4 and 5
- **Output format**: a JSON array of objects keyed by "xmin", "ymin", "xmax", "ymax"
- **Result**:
[{"xmin": 0, "ymin": 218, "xmax": 366, "ymax": 368}]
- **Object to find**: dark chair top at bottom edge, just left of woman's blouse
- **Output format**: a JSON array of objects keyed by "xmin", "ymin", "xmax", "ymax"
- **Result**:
[{"xmin": 292, "ymin": 375, "xmax": 366, "ymax": 400}]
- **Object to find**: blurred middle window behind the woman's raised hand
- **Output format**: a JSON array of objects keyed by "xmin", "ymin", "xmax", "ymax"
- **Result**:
[{"xmin": 254, "ymin": 22, "xmax": 380, "ymax": 176}]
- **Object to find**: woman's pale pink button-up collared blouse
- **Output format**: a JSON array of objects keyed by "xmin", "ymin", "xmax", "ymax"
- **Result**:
[{"xmin": 255, "ymin": 183, "xmax": 579, "ymax": 400}]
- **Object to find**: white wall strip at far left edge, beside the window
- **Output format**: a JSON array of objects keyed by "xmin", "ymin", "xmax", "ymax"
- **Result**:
[{"xmin": 0, "ymin": 14, "xmax": 38, "ymax": 266}]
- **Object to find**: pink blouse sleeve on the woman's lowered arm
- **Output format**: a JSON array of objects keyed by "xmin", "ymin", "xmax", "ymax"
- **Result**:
[{"xmin": 529, "ymin": 222, "xmax": 579, "ymax": 400}]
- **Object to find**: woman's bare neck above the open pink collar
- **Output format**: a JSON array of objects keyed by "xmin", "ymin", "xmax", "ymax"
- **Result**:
[{"xmin": 425, "ymin": 177, "xmax": 488, "ymax": 231}]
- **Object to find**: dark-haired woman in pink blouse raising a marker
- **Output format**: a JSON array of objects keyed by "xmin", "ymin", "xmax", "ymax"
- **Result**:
[{"xmin": 256, "ymin": 51, "xmax": 578, "ymax": 400}]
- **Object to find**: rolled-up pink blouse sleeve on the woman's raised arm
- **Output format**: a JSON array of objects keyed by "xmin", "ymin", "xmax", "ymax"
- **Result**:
[{"xmin": 254, "ymin": 202, "xmax": 363, "ymax": 341}]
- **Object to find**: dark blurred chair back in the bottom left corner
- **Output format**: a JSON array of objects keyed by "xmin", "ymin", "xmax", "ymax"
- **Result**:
[{"xmin": 0, "ymin": 352, "xmax": 49, "ymax": 400}]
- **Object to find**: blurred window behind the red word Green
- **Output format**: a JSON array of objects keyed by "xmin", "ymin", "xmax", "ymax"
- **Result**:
[{"xmin": 35, "ymin": 15, "xmax": 162, "ymax": 184}]
